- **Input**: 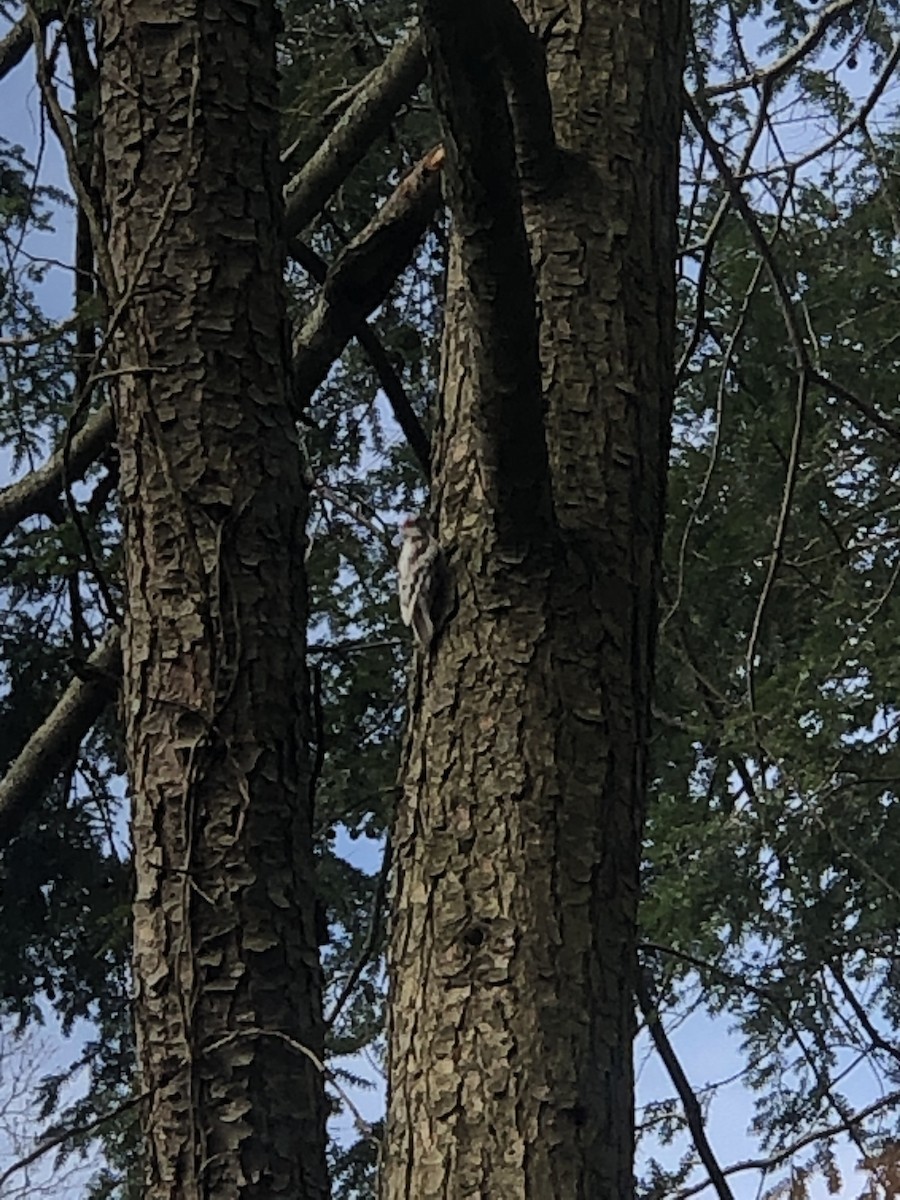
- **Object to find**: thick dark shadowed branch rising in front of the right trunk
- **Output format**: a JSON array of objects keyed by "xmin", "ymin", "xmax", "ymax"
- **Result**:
[{"xmin": 421, "ymin": 0, "xmax": 552, "ymax": 544}]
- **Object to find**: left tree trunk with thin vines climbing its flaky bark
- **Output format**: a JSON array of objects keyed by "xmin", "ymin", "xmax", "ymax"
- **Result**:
[{"xmin": 98, "ymin": 0, "xmax": 328, "ymax": 1200}]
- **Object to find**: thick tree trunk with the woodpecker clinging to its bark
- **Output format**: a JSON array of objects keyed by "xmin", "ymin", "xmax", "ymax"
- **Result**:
[{"xmin": 384, "ymin": 0, "xmax": 684, "ymax": 1200}]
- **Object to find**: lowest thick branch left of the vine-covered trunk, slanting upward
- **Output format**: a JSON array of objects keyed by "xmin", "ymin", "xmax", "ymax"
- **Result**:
[{"xmin": 0, "ymin": 625, "xmax": 121, "ymax": 842}]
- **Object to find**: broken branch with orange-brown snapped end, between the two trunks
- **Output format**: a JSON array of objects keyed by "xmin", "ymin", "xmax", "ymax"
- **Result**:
[{"xmin": 294, "ymin": 146, "xmax": 444, "ymax": 407}]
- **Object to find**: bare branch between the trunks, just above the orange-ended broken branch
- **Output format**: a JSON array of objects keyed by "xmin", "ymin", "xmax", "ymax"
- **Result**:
[{"xmin": 284, "ymin": 29, "xmax": 425, "ymax": 238}]
